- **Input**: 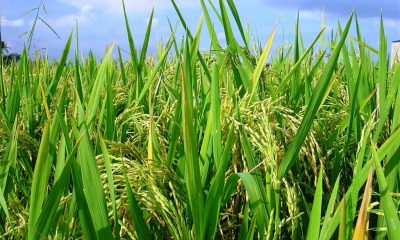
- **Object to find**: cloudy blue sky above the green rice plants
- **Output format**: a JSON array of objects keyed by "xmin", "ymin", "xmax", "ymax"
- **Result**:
[{"xmin": 0, "ymin": 0, "xmax": 400, "ymax": 59}]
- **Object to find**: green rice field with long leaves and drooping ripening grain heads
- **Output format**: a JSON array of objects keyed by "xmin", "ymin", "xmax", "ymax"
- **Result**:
[{"xmin": 0, "ymin": 0, "xmax": 400, "ymax": 240}]
